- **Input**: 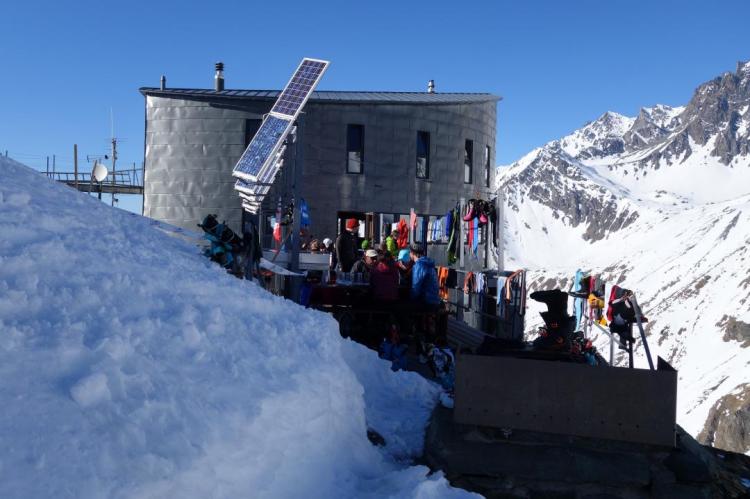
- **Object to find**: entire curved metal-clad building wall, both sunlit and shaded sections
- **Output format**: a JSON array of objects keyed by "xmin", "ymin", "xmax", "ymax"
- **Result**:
[{"xmin": 144, "ymin": 95, "xmax": 497, "ymax": 238}]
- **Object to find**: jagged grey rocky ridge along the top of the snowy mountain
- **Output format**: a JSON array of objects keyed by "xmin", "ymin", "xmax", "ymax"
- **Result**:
[{"xmin": 498, "ymin": 62, "xmax": 750, "ymax": 242}]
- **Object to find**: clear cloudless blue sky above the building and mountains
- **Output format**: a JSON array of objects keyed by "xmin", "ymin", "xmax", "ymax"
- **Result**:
[{"xmin": 0, "ymin": 0, "xmax": 750, "ymax": 211}]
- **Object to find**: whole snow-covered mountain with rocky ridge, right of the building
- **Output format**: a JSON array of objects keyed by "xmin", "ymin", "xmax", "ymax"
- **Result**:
[{"xmin": 498, "ymin": 63, "xmax": 750, "ymax": 452}]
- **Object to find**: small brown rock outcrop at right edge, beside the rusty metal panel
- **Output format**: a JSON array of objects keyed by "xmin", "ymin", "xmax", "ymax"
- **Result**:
[{"xmin": 698, "ymin": 384, "xmax": 750, "ymax": 453}]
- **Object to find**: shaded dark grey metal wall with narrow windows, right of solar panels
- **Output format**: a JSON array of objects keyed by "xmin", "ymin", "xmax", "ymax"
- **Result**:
[{"xmin": 264, "ymin": 102, "xmax": 497, "ymax": 238}]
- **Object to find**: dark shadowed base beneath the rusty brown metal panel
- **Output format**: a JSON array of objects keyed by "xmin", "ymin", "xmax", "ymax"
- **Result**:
[{"xmin": 424, "ymin": 407, "xmax": 750, "ymax": 499}]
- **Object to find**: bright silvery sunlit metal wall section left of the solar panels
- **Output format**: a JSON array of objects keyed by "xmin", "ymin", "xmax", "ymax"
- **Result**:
[{"xmin": 143, "ymin": 96, "xmax": 265, "ymax": 229}]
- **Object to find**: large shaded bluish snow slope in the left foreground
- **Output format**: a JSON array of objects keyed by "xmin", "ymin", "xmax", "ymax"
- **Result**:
[{"xmin": 0, "ymin": 158, "xmax": 478, "ymax": 498}]
